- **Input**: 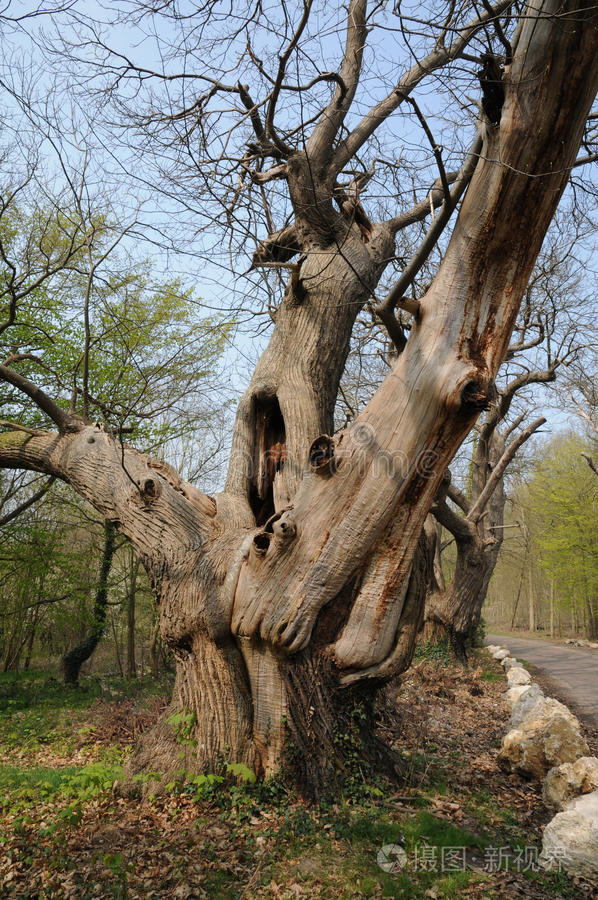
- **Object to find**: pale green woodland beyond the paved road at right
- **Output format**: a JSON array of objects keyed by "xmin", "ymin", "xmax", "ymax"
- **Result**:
[{"xmin": 483, "ymin": 430, "xmax": 598, "ymax": 641}]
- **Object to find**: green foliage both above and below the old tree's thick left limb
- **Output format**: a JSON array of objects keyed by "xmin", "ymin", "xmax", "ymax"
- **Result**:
[{"xmin": 0, "ymin": 194, "xmax": 232, "ymax": 668}]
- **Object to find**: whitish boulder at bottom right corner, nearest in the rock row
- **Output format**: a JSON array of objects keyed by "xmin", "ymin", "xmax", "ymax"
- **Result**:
[{"xmin": 539, "ymin": 791, "xmax": 598, "ymax": 881}]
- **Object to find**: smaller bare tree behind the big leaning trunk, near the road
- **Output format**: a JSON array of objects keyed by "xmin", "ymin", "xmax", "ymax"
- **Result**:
[{"xmin": 423, "ymin": 211, "xmax": 595, "ymax": 652}]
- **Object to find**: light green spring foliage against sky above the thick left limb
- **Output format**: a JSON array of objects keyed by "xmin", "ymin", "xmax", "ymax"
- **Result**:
[{"xmin": 0, "ymin": 200, "xmax": 231, "ymax": 448}]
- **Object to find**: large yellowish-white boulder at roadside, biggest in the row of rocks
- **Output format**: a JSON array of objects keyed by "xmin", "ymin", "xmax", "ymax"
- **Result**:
[{"xmin": 497, "ymin": 700, "xmax": 589, "ymax": 779}]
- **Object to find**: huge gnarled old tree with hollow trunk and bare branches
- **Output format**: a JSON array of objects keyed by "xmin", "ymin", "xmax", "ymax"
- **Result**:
[{"xmin": 0, "ymin": 0, "xmax": 598, "ymax": 793}]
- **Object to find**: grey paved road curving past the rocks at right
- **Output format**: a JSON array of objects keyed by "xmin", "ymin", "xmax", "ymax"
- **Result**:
[{"xmin": 487, "ymin": 634, "xmax": 598, "ymax": 728}]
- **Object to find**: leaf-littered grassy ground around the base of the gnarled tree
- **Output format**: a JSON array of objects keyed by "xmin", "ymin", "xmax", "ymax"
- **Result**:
[{"xmin": 0, "ymin": 648, "xmax": 592, "ymax": 900}]
